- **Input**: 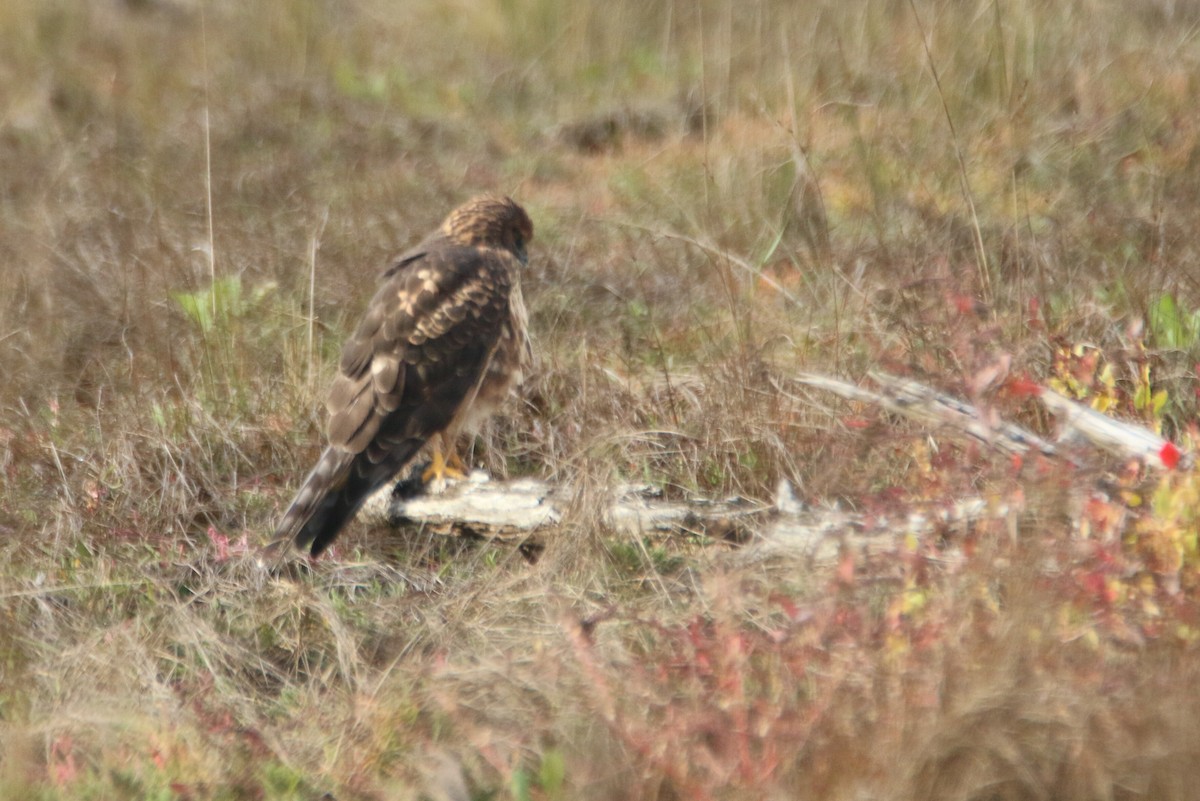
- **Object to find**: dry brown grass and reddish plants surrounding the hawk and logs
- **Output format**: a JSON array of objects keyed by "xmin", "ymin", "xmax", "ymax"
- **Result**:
[{"xmin": 0, "ymin": 0, "xmax": 1200, "ymax": 801}]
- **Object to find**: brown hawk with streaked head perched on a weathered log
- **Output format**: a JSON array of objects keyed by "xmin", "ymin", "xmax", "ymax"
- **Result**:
[{"xmin": 269, "ymin": 197, "xmax": 533, "ymax": 555}]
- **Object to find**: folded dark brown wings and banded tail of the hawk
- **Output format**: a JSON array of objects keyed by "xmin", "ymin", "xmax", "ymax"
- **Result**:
[{"xmin": 275, "ymin": 240, "xmax": 516, "ymax": 554}]
